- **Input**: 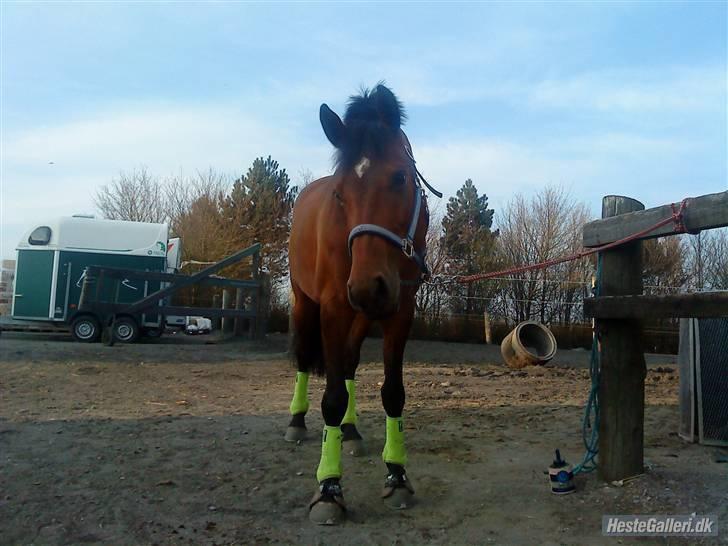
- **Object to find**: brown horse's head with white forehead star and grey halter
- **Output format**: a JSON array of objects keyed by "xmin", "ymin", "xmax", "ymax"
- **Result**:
[{"xmin": 320, "ymin": 85, "xmax": 428, "ymax": 319}]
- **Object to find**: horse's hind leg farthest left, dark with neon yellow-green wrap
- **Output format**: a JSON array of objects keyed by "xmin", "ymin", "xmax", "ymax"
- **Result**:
[{"xmin": 285, "ymin": 288, "xmax": 322, "ymax": 442}]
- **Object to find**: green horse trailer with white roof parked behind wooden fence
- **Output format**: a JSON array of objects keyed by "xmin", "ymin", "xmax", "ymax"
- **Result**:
[{"xmin": 12, "ymin": 216, "xmax": 172, "ymax": 341}]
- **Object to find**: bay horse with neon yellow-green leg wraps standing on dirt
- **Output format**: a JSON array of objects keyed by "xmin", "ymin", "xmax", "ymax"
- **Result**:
[{"xmin": 286, "ymin": 84, "xmax": 441, "ymax": 524}]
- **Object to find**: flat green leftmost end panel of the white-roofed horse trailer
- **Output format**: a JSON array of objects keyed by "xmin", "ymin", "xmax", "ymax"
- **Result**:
[{"xmin": 13, "ymin": 250, "xmax": 54, "ymax": 319}]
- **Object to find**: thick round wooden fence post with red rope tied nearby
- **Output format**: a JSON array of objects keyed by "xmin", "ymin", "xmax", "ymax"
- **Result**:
[{"xmin": 596, "ymin": 195, "xmax": 646, "ymax": 482}]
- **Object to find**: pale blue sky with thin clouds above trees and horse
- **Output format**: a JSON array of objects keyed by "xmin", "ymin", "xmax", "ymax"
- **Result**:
[{"xmin": 0, "ymin": 2, "xmax": 728, "ymax": 258}]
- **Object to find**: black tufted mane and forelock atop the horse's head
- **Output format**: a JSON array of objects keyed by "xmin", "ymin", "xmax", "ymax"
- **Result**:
[{"xmin": 336, "ymin": 83, "xmax": 407, "ymax": 169}]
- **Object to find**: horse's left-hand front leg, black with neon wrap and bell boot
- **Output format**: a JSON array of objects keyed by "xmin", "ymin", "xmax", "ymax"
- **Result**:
[{"xmin": 309, "ymin": 305, "xmax": 353, "ymax": 525}]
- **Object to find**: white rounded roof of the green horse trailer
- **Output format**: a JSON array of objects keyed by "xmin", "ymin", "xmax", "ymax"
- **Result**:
[{"xmin": 17, "ymin": 217, "xmax": 168, "ymax": 256}]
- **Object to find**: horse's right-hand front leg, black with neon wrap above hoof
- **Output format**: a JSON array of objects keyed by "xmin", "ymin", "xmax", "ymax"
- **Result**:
[{"xmin": 381, "ymin": 312, "xmax": 415, "ymax": 510}]
